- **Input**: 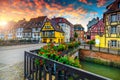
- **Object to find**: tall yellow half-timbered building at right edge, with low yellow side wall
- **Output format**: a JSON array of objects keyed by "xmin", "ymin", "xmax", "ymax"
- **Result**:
[{"xmin": 96, "ymin": 0, "xmax": 120, "ymax": 49}]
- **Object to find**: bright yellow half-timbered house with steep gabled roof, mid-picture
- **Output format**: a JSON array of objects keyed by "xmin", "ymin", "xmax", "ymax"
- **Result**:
[{"xmin": 40, "ymin": 20, "xmax": 64, "ymax": 43}]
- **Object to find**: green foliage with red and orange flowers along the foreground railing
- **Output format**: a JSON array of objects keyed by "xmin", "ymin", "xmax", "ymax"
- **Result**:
[{"xmin": 35, "ymin": 42, "xmax": 81, "ymax": 67}]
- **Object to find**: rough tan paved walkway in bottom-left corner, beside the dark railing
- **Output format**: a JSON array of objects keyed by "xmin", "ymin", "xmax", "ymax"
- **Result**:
[{"xmin": 0, "ymin": 62, "xmax": 24, "ymax": 80}]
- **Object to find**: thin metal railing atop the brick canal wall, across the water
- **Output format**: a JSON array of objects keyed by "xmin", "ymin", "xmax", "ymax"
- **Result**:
[{"xmin": 80, "ymin": 44, "xmax": 120, "ymax": 55}]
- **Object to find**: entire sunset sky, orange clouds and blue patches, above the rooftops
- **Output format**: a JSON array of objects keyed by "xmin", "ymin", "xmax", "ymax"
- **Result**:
[{"xmin": 0, "ymin": 0, "xmax": 114, "ymax": 30}]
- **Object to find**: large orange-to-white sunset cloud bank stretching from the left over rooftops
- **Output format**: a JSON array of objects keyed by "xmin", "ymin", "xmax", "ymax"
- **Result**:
[{"xmin": 0, "ymin": 0, "xmax": 97, "ymax": 31}]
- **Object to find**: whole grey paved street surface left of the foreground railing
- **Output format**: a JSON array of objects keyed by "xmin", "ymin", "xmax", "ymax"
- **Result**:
[{"xmin": 0, "ymin": 43, "xmax": 45, "ymax": 80}]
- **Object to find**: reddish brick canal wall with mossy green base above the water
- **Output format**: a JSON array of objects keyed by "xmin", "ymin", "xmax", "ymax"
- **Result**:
[{"xmin": 79, "ymin": 49, "xmax": 120, "ymax": 68}]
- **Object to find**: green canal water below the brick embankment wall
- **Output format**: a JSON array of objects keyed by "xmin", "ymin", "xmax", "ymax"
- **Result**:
[{"xmin": 81, "ymin": 61, "xmax": 120, "ymax": 80}]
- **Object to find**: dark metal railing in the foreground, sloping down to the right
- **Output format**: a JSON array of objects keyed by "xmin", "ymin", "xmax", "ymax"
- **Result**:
[{"xmin": 24, "ymin": 51, "xmax": 109, "ymax": 80}]
